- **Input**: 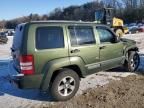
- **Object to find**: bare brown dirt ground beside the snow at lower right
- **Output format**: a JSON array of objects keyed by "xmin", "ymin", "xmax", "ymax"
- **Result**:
[{"xmin": 43, "ymin": 75, "xmax": 144, "ymax": 108}]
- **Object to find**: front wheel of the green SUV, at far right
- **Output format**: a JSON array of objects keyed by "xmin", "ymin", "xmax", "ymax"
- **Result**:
[{"xmin": 125, "ymin": 51, "xmax": 140, "ymax": 72}]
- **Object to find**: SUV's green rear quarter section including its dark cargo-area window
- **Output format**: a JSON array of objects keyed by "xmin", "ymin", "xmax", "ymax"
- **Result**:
[{"xmin": 28, "ymin": 24, "xmax": 69, "ymax": 73}]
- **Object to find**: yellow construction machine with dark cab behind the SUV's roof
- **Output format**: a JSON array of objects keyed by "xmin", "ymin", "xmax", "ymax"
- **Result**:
[{"xmin": 95, "ymin": 8, "xmax": 127, "ymax": 37}]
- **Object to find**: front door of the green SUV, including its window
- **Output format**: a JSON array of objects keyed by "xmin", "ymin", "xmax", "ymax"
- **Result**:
[{"xmin": 96, "ymin": 26, "xmax": 124, "ymax": 70}]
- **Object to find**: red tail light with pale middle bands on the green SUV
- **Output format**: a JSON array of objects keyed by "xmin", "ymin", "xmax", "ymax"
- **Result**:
[{"xmin": 20, "ymin": 55, "xmax": 34, "ymax": 75}]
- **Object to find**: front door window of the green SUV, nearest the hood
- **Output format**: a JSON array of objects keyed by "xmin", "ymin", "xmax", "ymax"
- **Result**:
[{"xmin": 96, "ymin": 28, "xmax": 114, "ymax": 42}]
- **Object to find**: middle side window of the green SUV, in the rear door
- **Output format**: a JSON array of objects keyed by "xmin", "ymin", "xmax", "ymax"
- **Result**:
[{"xmin": 68, "ymin": 26, "xmax": 96, "ymax": 46}]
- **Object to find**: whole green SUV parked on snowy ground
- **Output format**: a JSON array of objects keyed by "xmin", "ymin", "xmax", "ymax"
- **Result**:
[{"xmin": 11, "ymin": 21, "xmax": 140, "ymax": 101}]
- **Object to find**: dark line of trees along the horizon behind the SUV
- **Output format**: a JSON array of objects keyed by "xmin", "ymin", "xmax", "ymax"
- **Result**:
[{"xmin": 0, "ymin": 0, "xmax": 144, "ymax": 29}]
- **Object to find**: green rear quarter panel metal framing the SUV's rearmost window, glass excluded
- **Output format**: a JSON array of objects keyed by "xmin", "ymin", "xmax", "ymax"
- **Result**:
[{"xmin": 27, "ymin": 24, "xmax": 68, "ymax": 74}]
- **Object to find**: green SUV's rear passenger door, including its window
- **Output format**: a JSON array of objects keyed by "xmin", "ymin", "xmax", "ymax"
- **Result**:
[{"xmin": 68, "ymin": 25, "xmax": 100, "ymax": 74}]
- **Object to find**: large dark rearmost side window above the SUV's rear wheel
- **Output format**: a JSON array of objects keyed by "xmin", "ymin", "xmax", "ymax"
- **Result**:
[{"xmin": 36, "ymin": 27, "xmax": 64, "ymax": 49}]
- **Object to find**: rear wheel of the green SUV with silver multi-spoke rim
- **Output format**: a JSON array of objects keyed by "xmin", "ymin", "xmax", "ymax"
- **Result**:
[{"xmin": 50, "ymin": 69, "xmax": 80, "ymax": 101}]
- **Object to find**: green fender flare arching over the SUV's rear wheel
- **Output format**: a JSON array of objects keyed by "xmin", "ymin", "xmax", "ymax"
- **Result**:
[{"xmin": 40, "ymin": 58, "xmax": 85, "ymax": 91}]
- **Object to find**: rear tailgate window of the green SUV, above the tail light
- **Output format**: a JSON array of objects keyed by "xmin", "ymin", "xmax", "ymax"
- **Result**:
[{"xmin": 12, "ymin": 25, "xmax": 24, "ymax": 50}]
